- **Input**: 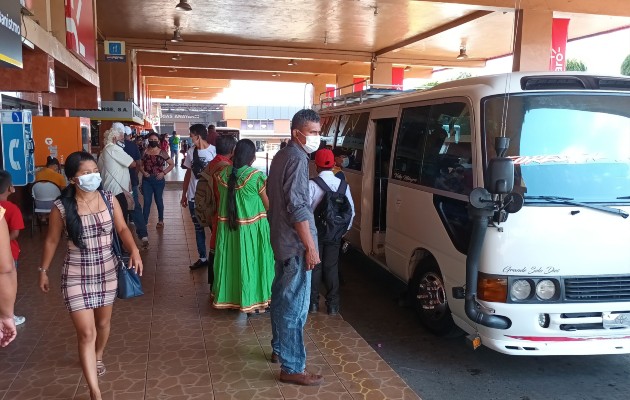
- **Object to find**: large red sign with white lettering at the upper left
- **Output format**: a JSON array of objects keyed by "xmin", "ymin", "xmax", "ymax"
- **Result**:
[{"xmin": 65, "ymin": 0, "xmax": 96, "ymax": 68}]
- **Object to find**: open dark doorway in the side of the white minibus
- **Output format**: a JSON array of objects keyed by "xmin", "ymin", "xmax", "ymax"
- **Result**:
[{"xmin": 372, "ymin": 118, "xmax": 396, "ymax": 262}]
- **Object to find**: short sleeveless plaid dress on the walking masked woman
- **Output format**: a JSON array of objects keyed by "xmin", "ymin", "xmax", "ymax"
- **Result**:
[{"xmin": 54, "ymin": 191, "xmax": 118, "ymax": 312}]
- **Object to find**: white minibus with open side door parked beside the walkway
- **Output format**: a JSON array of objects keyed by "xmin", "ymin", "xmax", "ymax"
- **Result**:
[{"xmin": 320, "ymin": 72, "xmax": 630, "ymax": 355}]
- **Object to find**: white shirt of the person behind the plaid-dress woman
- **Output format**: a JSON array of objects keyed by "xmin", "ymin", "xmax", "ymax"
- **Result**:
[{"xmin": 97, "ymin": 143, "xmax": 133, "ymax": 196}]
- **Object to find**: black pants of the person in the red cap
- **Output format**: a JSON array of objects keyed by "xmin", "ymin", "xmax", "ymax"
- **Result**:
[{"xmin": 311, "ymin": 243, "xmax": 341, "ymax": 307}]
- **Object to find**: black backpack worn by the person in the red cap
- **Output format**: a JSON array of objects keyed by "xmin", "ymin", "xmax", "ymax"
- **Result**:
[{"xmin": 313, "ymin": 176, "xmax": 352, "ymax": 244}]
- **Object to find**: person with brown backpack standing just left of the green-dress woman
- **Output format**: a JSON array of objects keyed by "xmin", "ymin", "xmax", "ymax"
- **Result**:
[{"xmin": 195, "ymin": 135, "xmax": 236, "ymax": 285}]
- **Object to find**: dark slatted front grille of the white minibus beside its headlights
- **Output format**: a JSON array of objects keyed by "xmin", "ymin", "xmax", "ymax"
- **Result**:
[{"xmin": 564, "ymin": 275, "xmax": 630, "ymax": 301}]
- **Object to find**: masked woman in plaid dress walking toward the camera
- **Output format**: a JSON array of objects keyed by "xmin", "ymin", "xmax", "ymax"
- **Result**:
[{"xmin": 39, "ymin": 152, "xmax": 142, "ymax": 399}]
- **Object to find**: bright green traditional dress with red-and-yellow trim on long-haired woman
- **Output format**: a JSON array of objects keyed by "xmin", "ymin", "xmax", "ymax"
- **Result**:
[{"xmin": 212, "ymin": 166, "xmax": 275, "ymax": 312}]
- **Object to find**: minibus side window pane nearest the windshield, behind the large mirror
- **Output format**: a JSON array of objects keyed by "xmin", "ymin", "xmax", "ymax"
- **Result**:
[{"xmin": 420, "ymin": 102, "xmax": 472, "ymax": 195}]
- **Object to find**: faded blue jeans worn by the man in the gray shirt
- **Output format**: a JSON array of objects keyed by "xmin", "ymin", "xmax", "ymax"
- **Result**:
[{"xmin": 271, "ymin": 254, "xmax": 311, "ymax": 374}]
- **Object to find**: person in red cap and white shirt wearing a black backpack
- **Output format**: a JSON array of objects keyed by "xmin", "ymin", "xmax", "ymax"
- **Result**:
[{"xmin": 308, "ymin": 149, "xmax": 354, "ymax": 315}]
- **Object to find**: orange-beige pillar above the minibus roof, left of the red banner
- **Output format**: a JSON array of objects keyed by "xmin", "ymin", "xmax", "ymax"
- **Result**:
[{"xmin": 512, "ymin": 10, "xmax": 553, "ymax": 71}]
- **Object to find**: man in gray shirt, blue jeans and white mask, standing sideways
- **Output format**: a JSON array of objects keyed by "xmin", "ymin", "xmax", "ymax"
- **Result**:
[{"xmin": 267, "ymin": 109, "xmax": 323, "ymax": 386}]
